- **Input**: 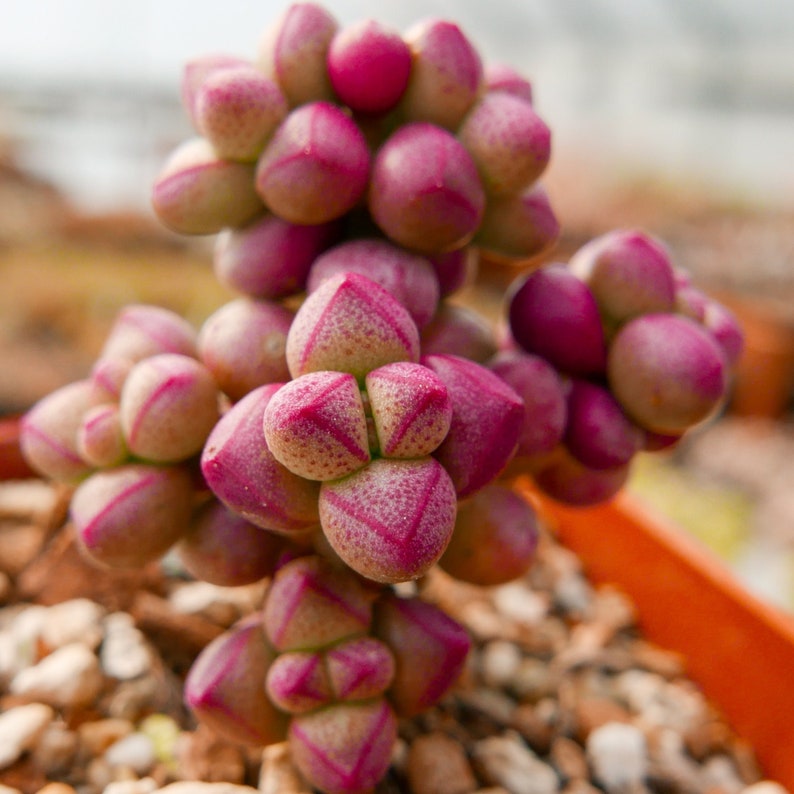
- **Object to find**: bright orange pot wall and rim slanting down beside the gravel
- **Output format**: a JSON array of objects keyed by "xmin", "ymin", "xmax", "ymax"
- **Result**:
[{"xmin": 519, "ymin": 478, "xmax": 794, "ymax": 790}]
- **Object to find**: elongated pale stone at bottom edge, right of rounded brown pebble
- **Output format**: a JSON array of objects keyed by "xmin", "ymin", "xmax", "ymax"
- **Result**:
[{"xmin": 472, "ymin": 734, "xmax": 560, "ymax": 794}]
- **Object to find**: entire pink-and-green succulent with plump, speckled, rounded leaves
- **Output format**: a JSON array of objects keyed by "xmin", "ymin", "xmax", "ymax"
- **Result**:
[{"xmin": 17, "ymin": 3, "xmax": 741, "ymax": 792}]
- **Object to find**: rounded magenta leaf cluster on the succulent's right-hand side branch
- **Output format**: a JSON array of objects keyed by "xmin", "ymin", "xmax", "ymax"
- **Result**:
[{"xmin": 502, "ymin": 230, "xmax": 742, "ymax": 505}]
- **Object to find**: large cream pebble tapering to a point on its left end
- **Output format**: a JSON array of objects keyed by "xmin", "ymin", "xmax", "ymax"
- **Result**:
[{"xmin": 9, "ymin": 642, "xmax": 103, "ymax": 706}]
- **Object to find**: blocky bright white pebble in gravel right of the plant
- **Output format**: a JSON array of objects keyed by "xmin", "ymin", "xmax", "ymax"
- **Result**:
[{"xmin": 585, "ymin": 722, "xmax": 648, "ymax": 791}]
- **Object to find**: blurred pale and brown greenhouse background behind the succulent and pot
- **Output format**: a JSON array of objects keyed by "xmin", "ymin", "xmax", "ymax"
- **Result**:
[{"xmin": 0, "ymin": 0, "xmax": 794, "ymax": 608}]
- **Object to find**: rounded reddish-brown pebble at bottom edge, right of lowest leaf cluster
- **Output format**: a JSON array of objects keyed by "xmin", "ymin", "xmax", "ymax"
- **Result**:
[{"xmin": 406, "ymin": 733, "xmax": 477, "ymax": 794}]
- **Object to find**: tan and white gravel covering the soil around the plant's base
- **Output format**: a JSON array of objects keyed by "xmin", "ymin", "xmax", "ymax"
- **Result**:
[{"xmin": 0, "ymin": 481, "xmax": 784, "ymax": 794}]
